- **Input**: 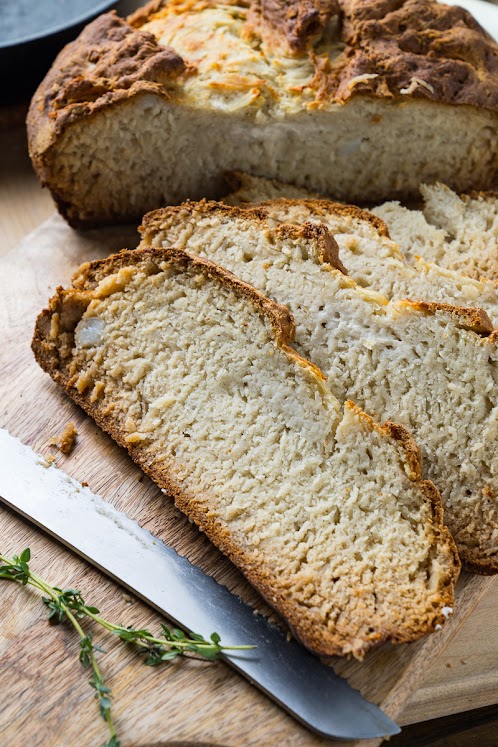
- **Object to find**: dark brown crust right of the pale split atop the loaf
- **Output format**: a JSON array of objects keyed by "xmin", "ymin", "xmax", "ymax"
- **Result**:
[{"xmin": 244, "ymin": 0, "xmax": 498, "ymax": 111}]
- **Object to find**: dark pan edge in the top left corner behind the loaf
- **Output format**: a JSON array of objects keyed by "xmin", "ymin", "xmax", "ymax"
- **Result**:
[{"xmin": 0, "ymin": 0, "xmax": 118, "ymax": 104}]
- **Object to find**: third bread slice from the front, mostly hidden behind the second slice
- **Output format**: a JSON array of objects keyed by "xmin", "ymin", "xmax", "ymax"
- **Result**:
[{"xmin": 223, "ymin": 173, "xmax": 498, "ymax": 327}]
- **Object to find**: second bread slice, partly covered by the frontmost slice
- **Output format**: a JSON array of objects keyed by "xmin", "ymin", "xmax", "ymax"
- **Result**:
[{"xmin": 141, "ymin": 203, "xmax": 498, "ymax": 573}]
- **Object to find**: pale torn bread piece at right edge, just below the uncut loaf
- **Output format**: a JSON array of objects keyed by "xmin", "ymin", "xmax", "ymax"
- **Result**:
[{"xmin": 372, "ymin": 184, "xmax": 498, "ymax": 281}]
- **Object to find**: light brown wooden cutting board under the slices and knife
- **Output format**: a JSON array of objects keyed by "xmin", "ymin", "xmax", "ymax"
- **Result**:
[{"xmin": 0, "ymin": 216, "xmax": 491, "ymax": 747}]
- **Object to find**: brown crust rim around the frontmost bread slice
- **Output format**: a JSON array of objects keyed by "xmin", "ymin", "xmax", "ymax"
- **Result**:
[{"xmin": 32, "ymin": 244, "xmax": 459, "ymax": 657}]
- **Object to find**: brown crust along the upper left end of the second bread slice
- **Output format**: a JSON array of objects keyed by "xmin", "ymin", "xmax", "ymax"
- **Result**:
[{"xmin": 138, "ymin": 200, "xmax": 350, "ymax": 275}]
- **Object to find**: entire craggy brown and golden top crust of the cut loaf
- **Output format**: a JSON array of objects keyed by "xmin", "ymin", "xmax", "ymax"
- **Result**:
[{"xmin": 28, "ymin": 0, "xmax": 498, "ymax": 152}]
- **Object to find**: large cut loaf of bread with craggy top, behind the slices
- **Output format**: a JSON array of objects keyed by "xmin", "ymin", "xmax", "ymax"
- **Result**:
[{"xmin": 28, "ymin": 0, "xmax": 498, "ymax": 225}]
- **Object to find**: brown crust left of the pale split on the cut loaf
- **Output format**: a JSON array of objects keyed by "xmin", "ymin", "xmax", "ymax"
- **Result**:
[{"xmin": 27, "ymin": 11, "xmax": 187, "ymax": 224}]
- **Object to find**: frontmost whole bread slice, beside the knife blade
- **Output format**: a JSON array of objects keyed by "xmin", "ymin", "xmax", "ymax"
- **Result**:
[{"xmin": 33, "ymin": 249, "xmax": 458, "ymax": 656}]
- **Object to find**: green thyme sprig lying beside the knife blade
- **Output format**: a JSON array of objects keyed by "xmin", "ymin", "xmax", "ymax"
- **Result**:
[{"xmin": 0, "ymin": 548, "xmax": 254, "ymax": 747}]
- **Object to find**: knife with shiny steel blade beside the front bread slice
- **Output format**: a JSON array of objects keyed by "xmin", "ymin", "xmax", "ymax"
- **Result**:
[{"xmin": 0, "ymin": 429, "xmax": 400, "ymax": 739}]
